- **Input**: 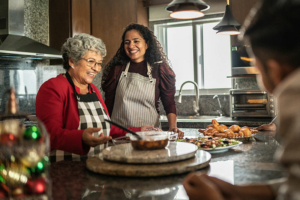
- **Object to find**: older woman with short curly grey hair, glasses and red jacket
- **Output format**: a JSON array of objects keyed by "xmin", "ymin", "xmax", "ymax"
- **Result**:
[{"xmin": 36, "ymin": 34, "xmax": 149, "ymax": 162}]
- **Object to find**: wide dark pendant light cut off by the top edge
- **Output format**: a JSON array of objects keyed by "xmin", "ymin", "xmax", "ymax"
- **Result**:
[{"xmin": 166, "ymin": 0, "xmax": 209, "ymax": 19}]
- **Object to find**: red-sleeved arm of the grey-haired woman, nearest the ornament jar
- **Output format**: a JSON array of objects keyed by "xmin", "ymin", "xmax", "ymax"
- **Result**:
[{"xmin": 36, "ymin": 80, "xmax": 90, "ymax": 155}]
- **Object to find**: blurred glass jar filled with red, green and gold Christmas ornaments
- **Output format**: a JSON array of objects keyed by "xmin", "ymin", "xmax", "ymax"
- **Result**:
[{"xmin": 0, "ymin": 89, "xmax": 51, "ymax": 200}]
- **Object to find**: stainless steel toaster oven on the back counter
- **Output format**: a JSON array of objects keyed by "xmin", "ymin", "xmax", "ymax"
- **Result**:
[{"xmin": 230, "ymin": 89, "xmax": 276, "ymax": 118}]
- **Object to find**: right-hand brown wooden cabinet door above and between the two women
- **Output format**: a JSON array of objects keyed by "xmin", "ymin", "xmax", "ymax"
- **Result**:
[{"xmin": 91, "ymin": 0, "xmax": 148, "ymax": 63}]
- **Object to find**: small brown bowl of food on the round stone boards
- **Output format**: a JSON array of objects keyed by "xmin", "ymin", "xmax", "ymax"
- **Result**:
[{"xmin": 130, "ymin": 131, "xmax": 170, "ymax": 150}]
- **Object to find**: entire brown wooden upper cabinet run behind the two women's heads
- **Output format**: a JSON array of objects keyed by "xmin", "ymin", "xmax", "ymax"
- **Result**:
[{"xmin": 49, "ymin": 0, "xmax": 148, "ymax": 63}]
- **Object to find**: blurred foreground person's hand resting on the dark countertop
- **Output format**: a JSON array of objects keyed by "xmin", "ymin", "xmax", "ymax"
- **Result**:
[{"xmin": 183, "ymin": 173, "xmax": 225, "ymax": 200}]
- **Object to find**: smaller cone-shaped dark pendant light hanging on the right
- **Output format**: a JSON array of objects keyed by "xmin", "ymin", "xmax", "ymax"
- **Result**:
[{"xmin": 213, "ymin": 0, "xmax": 241, "ymax": 35}]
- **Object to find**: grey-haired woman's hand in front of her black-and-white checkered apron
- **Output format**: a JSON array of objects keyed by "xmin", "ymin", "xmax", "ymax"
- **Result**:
[{"xmin": 82, "ymin": 128, "xmax": 111, "ymax": 147}]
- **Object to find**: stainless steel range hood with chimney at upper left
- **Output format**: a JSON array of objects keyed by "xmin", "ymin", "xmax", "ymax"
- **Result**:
[{"xmin": 0, "ymin": 0, "xmax": 62, "ymax": 59}]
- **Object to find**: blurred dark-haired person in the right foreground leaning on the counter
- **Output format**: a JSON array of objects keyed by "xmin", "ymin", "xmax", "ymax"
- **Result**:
[{"xmin": 183, "ymin": 0, "xmax": 300, "ymax": 200}]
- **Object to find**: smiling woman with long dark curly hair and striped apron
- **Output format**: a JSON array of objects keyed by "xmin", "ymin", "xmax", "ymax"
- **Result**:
[{"xmin": 102, "ymin": 24, "xmax": 183, "ymax": 138}]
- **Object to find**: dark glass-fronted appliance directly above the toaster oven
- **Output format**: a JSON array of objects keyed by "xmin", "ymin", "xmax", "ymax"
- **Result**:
[{"xmin": 231, "ymin": 45, "xmax": 259, "ymax": 76}]
